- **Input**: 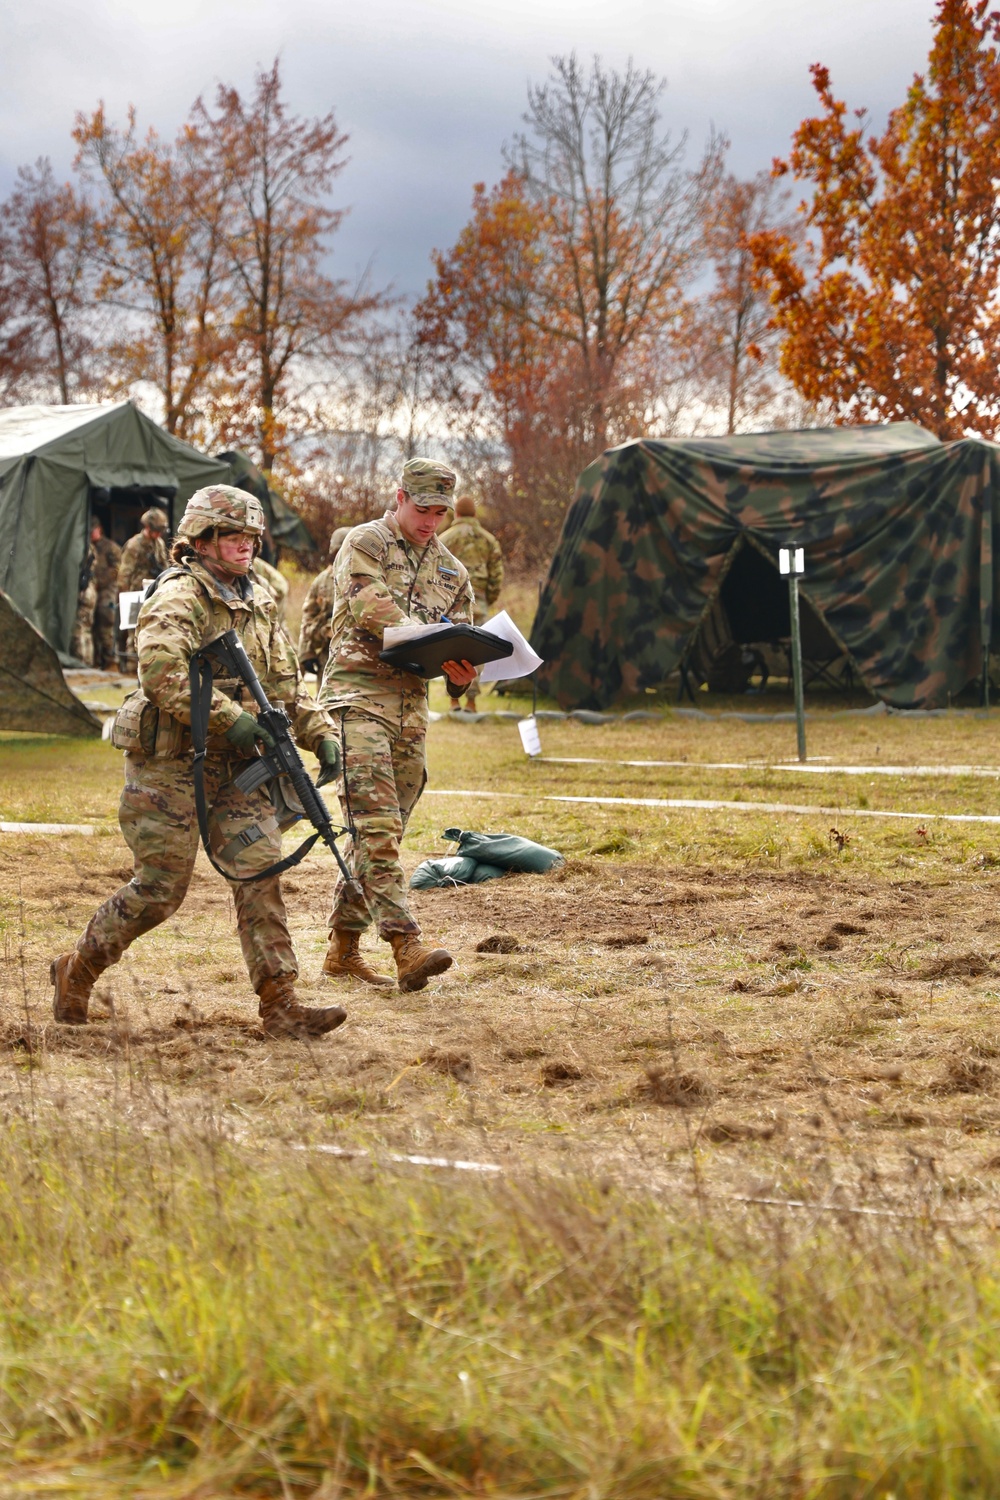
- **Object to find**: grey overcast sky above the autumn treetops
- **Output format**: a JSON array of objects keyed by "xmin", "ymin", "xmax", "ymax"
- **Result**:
[{"xmin": 0, "ymin": 0, "xmax": 934, "ymax": 293}]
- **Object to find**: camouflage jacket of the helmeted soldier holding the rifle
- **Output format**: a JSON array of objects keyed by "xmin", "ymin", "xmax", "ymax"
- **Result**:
[{"xmin": 135, "ymin": 560, "xmax": 336, "ymax": 756}]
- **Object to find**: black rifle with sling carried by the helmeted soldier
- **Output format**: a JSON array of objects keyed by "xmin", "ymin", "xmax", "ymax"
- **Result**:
[{"xmin": 190, "ymin": 630, "xmax": 363, "ymax": 900}]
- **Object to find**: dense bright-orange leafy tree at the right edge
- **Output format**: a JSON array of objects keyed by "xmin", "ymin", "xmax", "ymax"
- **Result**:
[{"xmin": 753, "ymin": 0, "xmax": 1000, "ymax": 438}]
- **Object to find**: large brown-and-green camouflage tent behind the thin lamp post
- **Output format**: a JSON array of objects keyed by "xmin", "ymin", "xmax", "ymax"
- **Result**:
[{"xmin": 531, "ymin": 423, "xmax": 1000, "ymax": 708}]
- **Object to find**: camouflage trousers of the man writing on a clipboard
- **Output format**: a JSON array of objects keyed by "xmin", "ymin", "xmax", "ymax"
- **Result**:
[{"xmin": 330, "ymin": 710, "xmax": 427, "ymax": 938}]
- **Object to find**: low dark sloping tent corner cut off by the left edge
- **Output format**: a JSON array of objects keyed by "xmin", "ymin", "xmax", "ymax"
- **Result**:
[{"xmin": 0, "ymin": 593, "xmax": 100, "ymax": 735}]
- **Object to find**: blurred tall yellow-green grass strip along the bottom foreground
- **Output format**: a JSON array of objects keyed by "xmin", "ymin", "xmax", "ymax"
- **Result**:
[{"xmin": 0, "ymin": 1116, "xmax": 1000, "ymax": 1500}]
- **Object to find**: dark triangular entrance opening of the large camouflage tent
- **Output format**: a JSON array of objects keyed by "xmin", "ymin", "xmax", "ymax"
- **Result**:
[{"xmin": 687, "ymin": 539, "xmax": 852, "ymax": 693}]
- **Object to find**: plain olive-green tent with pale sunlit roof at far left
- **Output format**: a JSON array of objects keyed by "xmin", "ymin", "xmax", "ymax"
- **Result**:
[{"xmin": 0, "ymin": 401, "xmax": 231, "ymax": 657}]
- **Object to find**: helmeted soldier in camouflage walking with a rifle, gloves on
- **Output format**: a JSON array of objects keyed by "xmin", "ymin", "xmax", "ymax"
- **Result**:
[{"xmin": 51, "ymin": 485, "xmax": 346, "ymax": 1037}]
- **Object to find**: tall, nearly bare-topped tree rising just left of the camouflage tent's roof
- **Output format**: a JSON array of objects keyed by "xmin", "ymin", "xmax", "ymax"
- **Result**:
[{"xmin": 507, "ymin": 54, "xmax": 726, "ymax": 446}]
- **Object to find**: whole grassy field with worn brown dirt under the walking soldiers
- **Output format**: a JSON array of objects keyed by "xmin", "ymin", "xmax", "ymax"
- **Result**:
[{"xmin": 0, "ymin": 690, "xmax": 1000, "ymax": 1500}]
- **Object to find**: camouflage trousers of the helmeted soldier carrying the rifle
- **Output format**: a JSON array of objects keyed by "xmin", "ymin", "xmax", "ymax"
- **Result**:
[{"xmin": 76, "ymin": 755, "xmax": 298, "ymax": 992}]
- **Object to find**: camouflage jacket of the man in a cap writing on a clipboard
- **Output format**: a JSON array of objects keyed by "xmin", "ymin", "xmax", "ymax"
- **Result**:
[{"xmin": 319, "ymin": 510, "xmax": 474, "ymax": 726}]
